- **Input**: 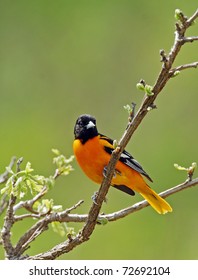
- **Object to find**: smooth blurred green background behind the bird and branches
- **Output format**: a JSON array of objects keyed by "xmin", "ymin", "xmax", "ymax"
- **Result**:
[{"xmin": 0, "ymin": 0, "xmax": 198, "ymax": 259}]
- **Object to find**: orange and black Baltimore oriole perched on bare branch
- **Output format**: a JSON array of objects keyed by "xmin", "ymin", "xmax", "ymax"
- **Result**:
[{"xmin": 73, "ymin": 115, "xmax": 172, "ymax": 214}]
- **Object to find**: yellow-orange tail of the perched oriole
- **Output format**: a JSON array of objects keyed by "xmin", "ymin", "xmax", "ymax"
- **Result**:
[{"xmin": 140, "ymin": 185, "xmax": 172, "ymax": 214}]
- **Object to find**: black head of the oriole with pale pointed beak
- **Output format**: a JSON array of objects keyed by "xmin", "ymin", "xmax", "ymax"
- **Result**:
[{"xmin": 74, "ymin": 115, "xmax": 98, "ymax": 144}]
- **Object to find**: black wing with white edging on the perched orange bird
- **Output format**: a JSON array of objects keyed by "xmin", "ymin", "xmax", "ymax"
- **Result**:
[{"xmin": 101, "ymin": 135, "xmax": 153, "ymax": 182}]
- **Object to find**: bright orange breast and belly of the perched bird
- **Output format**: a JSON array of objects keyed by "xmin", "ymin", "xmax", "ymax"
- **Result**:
[{"xmin": 73, "ymin": 136, "xmax": 145, "ymax": 191}]
